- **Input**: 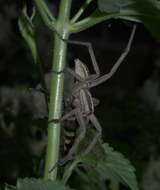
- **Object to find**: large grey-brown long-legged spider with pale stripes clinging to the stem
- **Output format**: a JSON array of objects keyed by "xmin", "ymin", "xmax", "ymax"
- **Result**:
[{"xmin": 49, "ymin": 25, "xmax": 136, "ymax": 171}]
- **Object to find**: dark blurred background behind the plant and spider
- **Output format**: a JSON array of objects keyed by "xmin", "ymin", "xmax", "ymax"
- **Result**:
[{"xmin": 0, "ymin": 0, "xmax": 160, "ymax": 190}]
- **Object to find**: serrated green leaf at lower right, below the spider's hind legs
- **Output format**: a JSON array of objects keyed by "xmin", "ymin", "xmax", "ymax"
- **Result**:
[{"xmin": 66, "ymin": 139, "xmax": 138, "ymax": 190}]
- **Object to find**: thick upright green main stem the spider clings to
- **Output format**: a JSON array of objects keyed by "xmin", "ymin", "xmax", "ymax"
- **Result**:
[{"xmin": 44, "ymin": 0, "xmax": 72, "ymax": 180}]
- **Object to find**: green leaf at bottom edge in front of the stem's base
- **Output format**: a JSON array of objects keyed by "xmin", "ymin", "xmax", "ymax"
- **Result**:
[{"xmin": 17, "ymin": 178, "xmax": 73, "ymax": 190}]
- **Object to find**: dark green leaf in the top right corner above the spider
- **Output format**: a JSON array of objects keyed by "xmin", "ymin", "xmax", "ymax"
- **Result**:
[{"xmin": 98, "ymin": 0, "xmax": 160, "ymax": 37}]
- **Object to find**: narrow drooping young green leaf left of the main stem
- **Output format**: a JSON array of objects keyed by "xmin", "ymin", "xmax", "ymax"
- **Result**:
[{"xmin": 18, "ymin": 7, "xmax": 38, "ymax": 62}]
